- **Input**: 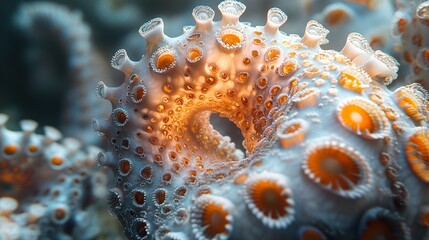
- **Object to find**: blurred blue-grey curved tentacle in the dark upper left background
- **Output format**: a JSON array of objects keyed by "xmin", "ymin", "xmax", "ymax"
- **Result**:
[{"xmin": 16, "ymin": 2, "xmax": 109, "ymax": 144}]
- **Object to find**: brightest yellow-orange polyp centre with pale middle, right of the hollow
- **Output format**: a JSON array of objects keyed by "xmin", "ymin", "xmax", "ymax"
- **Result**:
[{"xmin": 339, "ymin": 104, "xmax": 375, "ymax": 133}]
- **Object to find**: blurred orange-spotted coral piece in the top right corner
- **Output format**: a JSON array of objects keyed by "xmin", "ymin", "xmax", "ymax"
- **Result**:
[{"xmin": 393, "ymin": 0, "xmax": 429, "ymax": 89}]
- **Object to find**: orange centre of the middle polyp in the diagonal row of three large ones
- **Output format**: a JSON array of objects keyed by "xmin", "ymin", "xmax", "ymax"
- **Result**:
[{"xmin": 250, "ymin": 180, "xmax": 290, "ymax": 219}]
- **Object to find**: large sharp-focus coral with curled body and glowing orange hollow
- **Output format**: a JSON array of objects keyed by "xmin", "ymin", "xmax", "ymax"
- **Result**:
[{"xmin": 93, "ymin": 0, "xmax": 429, "ymax": 239}]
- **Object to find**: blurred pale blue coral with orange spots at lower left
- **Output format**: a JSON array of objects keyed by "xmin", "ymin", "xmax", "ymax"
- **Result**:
[{"xmin": 0, "ymin": 114, "xmax": 107, "ymax": 240}]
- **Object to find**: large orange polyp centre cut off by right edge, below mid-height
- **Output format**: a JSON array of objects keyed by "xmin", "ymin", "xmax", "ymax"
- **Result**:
[{"xmin": 405, "ymin": 129, "xmax": 429, "ymax": 183}]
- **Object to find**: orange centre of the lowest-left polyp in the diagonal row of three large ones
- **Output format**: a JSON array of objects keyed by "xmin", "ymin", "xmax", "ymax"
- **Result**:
[{"xmin": 201, "ymin": 203, "xmax": 230, "ymax": 239}]
